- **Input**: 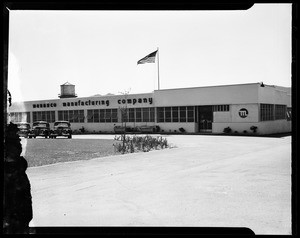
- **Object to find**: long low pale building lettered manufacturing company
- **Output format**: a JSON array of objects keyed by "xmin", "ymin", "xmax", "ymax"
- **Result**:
[{"xmin": 8, "ymin": 83, "xmax": 291, "ymax": 135}]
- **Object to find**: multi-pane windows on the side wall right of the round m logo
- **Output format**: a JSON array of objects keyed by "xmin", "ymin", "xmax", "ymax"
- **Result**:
[{"xmin": 260, "ymin": 104, "xmax": 287, "ymax": 121}]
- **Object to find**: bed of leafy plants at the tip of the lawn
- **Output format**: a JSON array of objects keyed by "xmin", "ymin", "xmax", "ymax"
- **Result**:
[{"xmin": 113, "ymin": 135, "xmax": 169, "ymax": 154}]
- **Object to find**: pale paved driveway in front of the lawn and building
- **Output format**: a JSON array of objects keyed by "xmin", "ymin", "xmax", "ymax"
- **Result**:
[{"xmin": 27, "ymin": 135, "xmax": 291, "ymax": 234}]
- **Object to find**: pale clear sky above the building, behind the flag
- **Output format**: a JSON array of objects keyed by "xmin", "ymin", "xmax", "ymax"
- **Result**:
[{"xmin": 8, "ymin": 4, "xmax": 292, "ymax": 101}]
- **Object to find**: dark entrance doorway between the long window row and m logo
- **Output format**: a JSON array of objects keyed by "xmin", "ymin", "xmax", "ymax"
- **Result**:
[{"xmin": 198, "ymin": 106, "xmax": 213, "ymax": 132}]
